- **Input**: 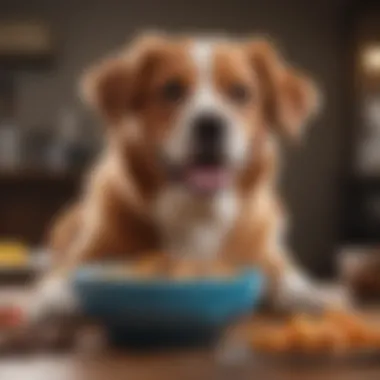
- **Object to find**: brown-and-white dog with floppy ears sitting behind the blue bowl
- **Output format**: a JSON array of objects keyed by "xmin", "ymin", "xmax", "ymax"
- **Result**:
[{"xmin": 27, "ymin": 33, "xmax": 350, "ymax": 318}]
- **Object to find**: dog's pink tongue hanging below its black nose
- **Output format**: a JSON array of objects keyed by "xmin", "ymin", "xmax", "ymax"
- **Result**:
[{"xmin": 187, "ymin": 167, "xmax": 228, "ymax": 193}]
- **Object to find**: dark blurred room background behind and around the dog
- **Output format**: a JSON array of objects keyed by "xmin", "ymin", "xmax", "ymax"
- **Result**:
[{"xmin": 0, "ymin": 0, "xmax": 380, "ymax": 284}]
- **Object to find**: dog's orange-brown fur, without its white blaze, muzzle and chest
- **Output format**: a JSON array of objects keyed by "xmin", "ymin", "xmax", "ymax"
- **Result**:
[{"xmin": 44, "ymin": 37, "xmax": 318, "ymax": 302}]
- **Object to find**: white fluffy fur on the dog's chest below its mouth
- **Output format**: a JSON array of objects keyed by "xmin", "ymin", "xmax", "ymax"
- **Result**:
[{"xmin": 155, "ymin": 188, "xmax": 238, "ymax": 258}]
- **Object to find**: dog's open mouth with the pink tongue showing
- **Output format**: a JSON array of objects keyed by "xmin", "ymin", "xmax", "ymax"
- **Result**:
[{"xmin": 182, "ymin": 165, "xmax": 231, "ymax": 194}]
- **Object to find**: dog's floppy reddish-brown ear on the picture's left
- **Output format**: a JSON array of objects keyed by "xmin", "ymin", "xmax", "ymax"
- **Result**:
[{"xmin": 81, "ymin": 35, "xmax": 166, "ymax": 124}]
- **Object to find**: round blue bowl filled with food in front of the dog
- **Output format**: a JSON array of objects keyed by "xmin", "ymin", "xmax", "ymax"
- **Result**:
[{"xmin": 74, "ymin": 265, "xmax": 264, "ymax": 347}]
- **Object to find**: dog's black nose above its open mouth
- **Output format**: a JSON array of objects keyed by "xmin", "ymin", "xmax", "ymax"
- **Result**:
[{"xmin": 194, "ymin": 113, "xmax": 225, "ymax": 148}]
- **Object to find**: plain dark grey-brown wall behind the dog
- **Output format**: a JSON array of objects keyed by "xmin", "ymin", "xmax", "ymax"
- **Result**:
[{"xmin": 0, "ymin": 0, "xmax": 343, "ymax": 271}]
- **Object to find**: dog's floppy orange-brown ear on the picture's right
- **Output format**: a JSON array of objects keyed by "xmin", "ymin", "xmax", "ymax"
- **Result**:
[{"xmin": 246, "ymin": 39, "xmax": 321, "ymax": 137}]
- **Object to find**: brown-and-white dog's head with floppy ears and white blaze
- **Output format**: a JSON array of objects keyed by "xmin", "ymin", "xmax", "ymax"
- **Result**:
[{"xmin": 84, "ymin": 36, "xmax": 318, "ymax": 194}]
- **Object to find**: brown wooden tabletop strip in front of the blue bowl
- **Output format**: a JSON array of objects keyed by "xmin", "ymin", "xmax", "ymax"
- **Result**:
[{"xmin": 0, "ymin": 352, "xmax": 380, "ymax": 380}]
